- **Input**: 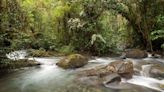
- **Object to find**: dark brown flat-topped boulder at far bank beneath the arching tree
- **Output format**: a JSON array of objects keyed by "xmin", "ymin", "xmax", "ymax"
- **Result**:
[{"xmin": 122, "ymin": 49, "xmax": 148, "ymax": 58}]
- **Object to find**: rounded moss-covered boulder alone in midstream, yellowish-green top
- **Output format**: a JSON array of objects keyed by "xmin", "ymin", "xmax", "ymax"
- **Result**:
[{"xmin": 56, "ymin": 54, "xmax": 88, "ymax": 69}]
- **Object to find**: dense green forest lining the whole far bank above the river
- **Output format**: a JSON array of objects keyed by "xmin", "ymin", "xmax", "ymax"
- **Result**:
[{"xmin": 0, "ymin": 0, "xmax": 164, "ymax": 56}]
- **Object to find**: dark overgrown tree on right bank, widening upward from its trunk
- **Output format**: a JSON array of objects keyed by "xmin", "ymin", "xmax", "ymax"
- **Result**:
[{"xmin": 106, "ymin": 0, "xmax": 164, "ymax": 51}]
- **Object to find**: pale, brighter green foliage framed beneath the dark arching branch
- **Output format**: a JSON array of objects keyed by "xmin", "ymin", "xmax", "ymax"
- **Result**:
[{"xmin": 100, "ymin": 12, "xmax": 131, "ymax": 50}]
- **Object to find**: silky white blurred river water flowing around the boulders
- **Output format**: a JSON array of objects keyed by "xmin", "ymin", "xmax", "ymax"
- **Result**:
[{"xmin": 0, "ymin": 51, "xmax": 164, "ymax": 92}]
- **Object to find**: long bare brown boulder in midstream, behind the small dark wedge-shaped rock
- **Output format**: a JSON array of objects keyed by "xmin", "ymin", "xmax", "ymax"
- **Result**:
[{"xmin": 80, "ymin": 61, "xmax": 133, "ymax": 78}]
